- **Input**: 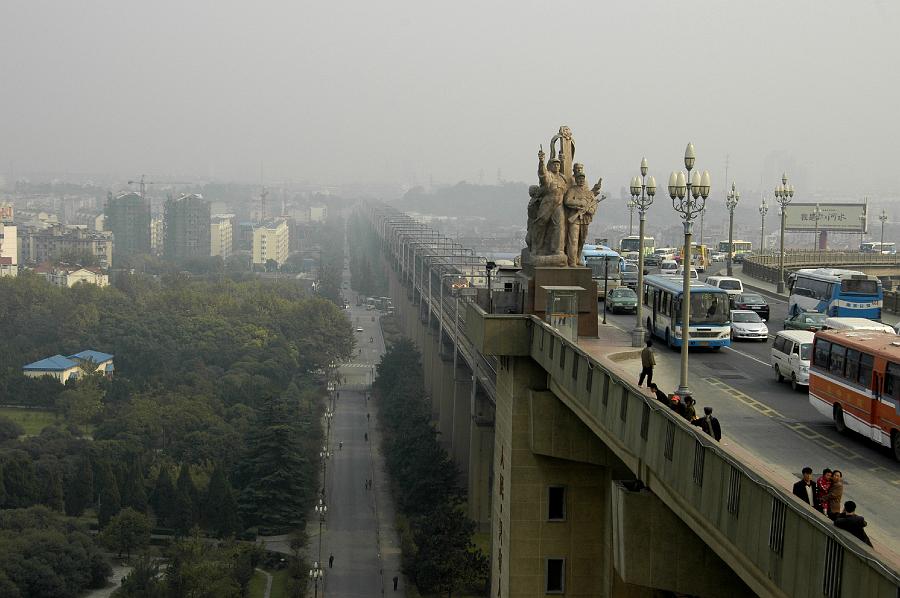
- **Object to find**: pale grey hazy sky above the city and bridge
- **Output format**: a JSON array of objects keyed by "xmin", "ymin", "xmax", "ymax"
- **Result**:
[{"xmin": 0, "ymin": 0, "xmax": 900, "ymax": 196}]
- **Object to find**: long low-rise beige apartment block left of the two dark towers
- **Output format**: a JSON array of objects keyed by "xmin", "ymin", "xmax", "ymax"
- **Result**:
[{"xmin": 20, "ymin": 224, "xmax": 113, "ymax": 268}]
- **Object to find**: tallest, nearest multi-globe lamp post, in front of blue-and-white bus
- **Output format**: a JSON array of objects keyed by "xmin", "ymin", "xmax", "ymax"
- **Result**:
[{"xmin": 669, "ymin": 143, "xmax": 710, "ymax": 396}]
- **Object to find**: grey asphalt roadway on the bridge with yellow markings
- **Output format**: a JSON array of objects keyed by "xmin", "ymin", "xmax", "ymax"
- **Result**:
[{"xmin": 600, "ymin": 264, "xmax": 900, "ymax": 555}]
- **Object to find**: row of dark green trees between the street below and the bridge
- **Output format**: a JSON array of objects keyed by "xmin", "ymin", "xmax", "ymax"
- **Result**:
[{"xmin": 374, "ymin": 339, "xmax": 488, "ymax": 596}]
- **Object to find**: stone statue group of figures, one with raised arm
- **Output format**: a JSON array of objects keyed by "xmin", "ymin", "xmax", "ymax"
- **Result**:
[{"xmin": 525, "ymin": 126, "xmax": 603, "ymax": 267}]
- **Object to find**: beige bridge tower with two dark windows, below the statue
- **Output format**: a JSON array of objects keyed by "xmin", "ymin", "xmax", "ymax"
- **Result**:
[{"xmin": 491, "ymin": 357, "xmax": 624, "ymax": 598}]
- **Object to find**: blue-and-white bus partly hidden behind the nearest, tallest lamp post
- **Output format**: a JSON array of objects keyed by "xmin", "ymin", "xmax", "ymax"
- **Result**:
[{"xmin": 642, "ymin": 274, "xmax": 731, "ymax": 349}]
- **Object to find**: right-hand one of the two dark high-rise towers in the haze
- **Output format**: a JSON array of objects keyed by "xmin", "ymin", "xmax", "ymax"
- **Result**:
[{"xmin": 164, "ymin": 193, "xmax": 210, "ymax": 260}]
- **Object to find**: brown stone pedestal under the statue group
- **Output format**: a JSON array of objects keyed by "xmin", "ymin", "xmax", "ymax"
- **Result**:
[{"xmin": 519, "ymin": 266, "xmax": 598, "ymax": 338}]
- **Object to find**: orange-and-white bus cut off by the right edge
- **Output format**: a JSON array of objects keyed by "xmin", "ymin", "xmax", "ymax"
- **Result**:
[{"xmin": 809, "ymin": 330, "xmax": 900, "ymax": 460}]
